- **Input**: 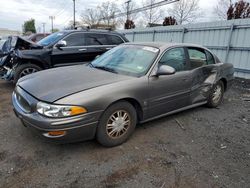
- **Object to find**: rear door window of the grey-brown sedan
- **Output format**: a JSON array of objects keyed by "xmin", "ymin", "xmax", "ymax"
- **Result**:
[{"xmin": 188, "ymin": 48, "xmax": 207, "ymax": 69}]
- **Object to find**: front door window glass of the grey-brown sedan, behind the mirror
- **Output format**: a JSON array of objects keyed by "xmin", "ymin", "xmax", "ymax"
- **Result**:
[{"xmin": 160, "ymin": 48, "xmax": 186, "ymax": 72}]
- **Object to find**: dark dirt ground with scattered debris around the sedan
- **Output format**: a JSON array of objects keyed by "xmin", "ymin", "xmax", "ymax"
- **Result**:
[{"xmin": 0, "ymin": 80, "xmax": 250, "ymax": 188}]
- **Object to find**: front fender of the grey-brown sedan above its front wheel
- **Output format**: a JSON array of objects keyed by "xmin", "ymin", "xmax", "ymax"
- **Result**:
[{"xmin": 54, "ymin": 77, "xmax": 150, "ymax": 117}]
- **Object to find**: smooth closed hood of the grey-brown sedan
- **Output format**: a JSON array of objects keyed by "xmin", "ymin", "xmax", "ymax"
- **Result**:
[{"xmin": 17, "ymin": 65, "xmax": 132, "ymax": 103}]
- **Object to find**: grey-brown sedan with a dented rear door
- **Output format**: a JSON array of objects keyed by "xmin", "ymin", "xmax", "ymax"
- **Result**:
[{"xmin": 12, "ymin": 43, "xmax": 234, "ymax": 146}]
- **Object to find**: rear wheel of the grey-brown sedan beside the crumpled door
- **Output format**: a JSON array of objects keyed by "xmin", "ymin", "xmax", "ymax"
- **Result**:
[{"xmin": 207, "ymin": 80, "xmax": 225, "ymax": 108}]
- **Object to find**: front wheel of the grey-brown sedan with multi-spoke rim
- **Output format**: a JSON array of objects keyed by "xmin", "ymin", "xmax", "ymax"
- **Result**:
[{"xmin": 96, "ymin": 102, "xmax": 137, "ymax": 147}]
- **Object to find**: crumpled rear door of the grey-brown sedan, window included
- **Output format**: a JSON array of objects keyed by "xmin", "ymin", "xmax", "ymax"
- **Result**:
[{"xmin": 187, "ymin": 47, "xmax": 219, "ymax": 104}]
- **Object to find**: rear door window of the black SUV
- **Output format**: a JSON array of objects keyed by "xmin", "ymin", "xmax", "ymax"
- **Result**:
[{"xmin": 85, "ymin": 33, "xmax": 108, "ymax": 46}]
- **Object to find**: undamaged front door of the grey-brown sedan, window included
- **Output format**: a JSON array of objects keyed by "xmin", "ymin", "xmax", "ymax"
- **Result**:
[{"xmin": 148, "ymin": 47, "xmax": 192, "ymax": 118}]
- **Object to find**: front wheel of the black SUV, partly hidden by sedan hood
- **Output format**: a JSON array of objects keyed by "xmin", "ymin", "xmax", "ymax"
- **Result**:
[{"xmin": 13, "ymin": 63, "xmax": 42, "ymax": 83}]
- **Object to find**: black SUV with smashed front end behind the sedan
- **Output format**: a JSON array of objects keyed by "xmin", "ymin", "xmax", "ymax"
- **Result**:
[{"xmin": 0, "ymin": 29, "xmax": 128, "ymax": 83}]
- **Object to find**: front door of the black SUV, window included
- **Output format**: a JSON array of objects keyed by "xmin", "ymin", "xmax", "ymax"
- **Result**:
[{"xmin": 51, "ymin": 32, "xmax": 89, "ymax": 67}]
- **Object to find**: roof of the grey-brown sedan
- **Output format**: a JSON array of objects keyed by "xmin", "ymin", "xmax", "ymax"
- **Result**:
[{"xmin": 125, "ymin": 42, "xmax": 206, "ymax": 50}]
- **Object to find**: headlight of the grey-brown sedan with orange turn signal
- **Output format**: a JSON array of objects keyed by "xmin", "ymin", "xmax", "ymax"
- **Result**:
[{"xmin": 36, "ymin": 102, "xmax": 87, "ymax": 118}]
